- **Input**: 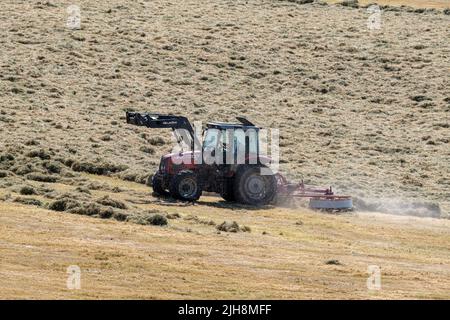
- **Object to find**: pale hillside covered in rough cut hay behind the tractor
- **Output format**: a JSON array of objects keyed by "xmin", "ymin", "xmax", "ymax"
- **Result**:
[{"xmin": 0, "ymin": 0, "xmax": 450, "ymax": 216}]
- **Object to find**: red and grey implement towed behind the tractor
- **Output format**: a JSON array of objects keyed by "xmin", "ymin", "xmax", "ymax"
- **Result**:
[{"xmin": 276, "ymin": 173, "xmax": 353, "ymax": 211}]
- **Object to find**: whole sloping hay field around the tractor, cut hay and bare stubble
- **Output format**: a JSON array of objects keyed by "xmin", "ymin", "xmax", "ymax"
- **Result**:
[{"xmin": 0, "ymin": 0, "xmax": 450, "ymax": 299}]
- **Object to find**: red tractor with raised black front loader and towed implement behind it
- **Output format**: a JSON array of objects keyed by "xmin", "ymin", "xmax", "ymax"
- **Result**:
[{"xmin": 126, "ymin": 112, "xmax": 352, "ymax": 209}]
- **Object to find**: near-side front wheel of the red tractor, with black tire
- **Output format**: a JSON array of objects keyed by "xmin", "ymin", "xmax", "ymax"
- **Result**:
[{"xmin": 169, "ymin": 170, "xmax": 202, "ymax": 201}]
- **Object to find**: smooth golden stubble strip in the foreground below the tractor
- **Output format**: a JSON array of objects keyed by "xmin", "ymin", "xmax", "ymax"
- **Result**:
[{"xmin": 0, "ymin": 177, "xmax": 450, "ymax": 299}]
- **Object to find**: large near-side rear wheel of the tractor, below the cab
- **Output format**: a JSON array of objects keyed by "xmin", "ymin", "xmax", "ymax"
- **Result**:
[{"xmin": 234, "ymin": 165, "xmax": 277, "ymax": 206}]
